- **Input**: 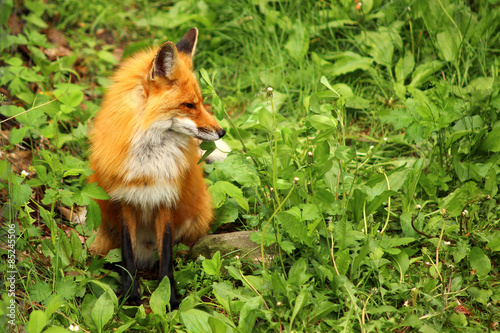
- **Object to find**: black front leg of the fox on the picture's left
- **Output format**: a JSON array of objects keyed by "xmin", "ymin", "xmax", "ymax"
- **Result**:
[{"xmin": 121, "ymin": 219, "xmax": 142, "ymax": 305}]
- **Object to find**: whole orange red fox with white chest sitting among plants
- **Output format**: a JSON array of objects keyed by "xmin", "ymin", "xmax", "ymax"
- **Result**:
[{"xmin": 89, "ymin": 28, "xmax": 226, "ymax": 308}]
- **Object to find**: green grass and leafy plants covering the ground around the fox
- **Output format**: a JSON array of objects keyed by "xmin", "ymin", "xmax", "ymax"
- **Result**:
[{"xmin": 0, "ymin": 0, "xmax": 500, "ymax": 333}]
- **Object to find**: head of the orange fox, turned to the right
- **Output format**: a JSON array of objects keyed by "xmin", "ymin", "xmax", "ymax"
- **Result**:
[{"xmin": 141, "ymin": 28, "xmax": 226, "ymax": 141}]
